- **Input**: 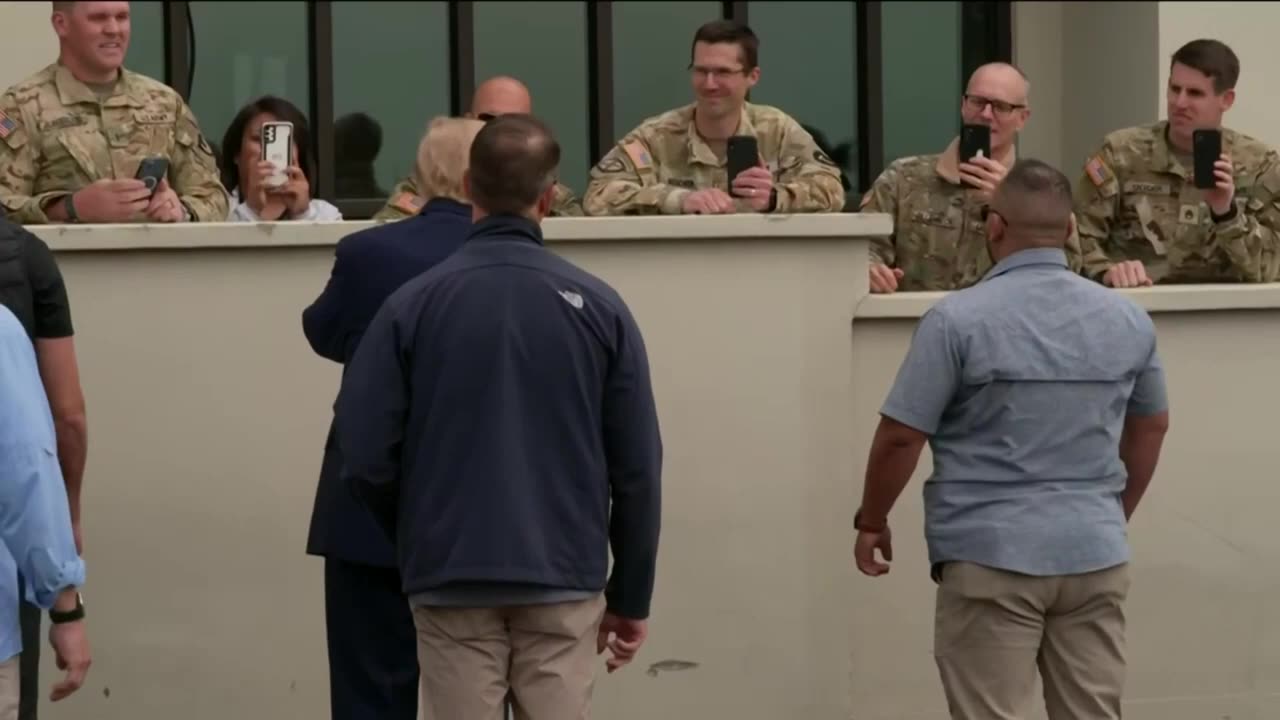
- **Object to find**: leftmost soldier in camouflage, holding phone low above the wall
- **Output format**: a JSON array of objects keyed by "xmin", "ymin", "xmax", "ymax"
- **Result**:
[{"xmin": 0, "ymin": 3, "xmax": 228, "ymax": 224}]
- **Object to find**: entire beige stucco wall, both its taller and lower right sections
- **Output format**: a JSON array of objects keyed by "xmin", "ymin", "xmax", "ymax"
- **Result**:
[{"xmin": 17, "ymin": 215, "xmax": 1280, "ymax": 720}]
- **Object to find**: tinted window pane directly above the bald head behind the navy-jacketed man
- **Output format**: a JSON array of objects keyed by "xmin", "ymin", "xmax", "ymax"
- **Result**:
[{"xmin": 467, "ymin": 0, "xmax": 594, "ymax": 195}]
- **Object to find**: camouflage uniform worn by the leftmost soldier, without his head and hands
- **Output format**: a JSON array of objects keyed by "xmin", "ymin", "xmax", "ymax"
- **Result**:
[{"xmin": 0, "ymin": 64, "xmax": 229, "ymax": 224}]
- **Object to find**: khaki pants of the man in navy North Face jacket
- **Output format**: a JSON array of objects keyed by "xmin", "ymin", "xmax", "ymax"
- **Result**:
[{"xmin": 412, "ymin": 594, "xmax": 604, "ymax": 720}]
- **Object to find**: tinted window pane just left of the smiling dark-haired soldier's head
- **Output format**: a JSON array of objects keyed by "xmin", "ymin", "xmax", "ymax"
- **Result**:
[{"xmin": 612, "ymin": 0, "xmax": 722, "ymax": 138}]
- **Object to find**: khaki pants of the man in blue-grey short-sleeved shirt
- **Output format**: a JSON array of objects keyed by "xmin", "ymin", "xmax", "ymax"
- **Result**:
[{"xmin": 933, "ymin": 562, "xmax": 1129, "ymax": 720}]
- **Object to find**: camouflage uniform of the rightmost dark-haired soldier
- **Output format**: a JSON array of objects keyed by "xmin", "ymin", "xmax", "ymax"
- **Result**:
[{"xmin": 1075, "ymin": 122, "xmax": 1280, "ymax": 283}]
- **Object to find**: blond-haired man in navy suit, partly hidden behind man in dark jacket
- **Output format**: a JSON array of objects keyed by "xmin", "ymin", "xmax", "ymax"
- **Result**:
[{"xmin": 302, "ymin": 118, "xmax": 484, "ymax": 720}]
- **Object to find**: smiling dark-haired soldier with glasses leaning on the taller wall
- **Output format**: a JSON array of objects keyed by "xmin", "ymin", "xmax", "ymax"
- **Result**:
[{"xmin": 582, "ymin": 20, "xmax": 845, "ymax": 215}]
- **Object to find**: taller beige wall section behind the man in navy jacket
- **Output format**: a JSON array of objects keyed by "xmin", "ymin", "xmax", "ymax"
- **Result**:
[{"xmin": 35, "ymin": 217, "xmax": 888, "ymax": 720}]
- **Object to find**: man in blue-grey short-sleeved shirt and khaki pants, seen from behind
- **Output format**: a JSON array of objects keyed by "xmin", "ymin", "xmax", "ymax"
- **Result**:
[{"xmin": 854, "ymin": 160, "xmax": 1169, "ymax": 720}]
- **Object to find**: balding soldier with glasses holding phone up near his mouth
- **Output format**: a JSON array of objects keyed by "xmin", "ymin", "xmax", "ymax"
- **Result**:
[{"xmin": 859, "ymin": 63, "xmax": 1083, "ymax": 292}]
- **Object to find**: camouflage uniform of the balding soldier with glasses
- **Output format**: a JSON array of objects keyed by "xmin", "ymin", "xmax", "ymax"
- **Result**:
[{"xmin": 859, "ymin": 141, "xmax": 1083, "ymax": 292}]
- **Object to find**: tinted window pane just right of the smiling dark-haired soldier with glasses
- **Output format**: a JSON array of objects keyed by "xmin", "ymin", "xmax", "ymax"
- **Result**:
[{"xmin": 748, "ymin": 0, "xmax": 860, "ymax": 193}]
